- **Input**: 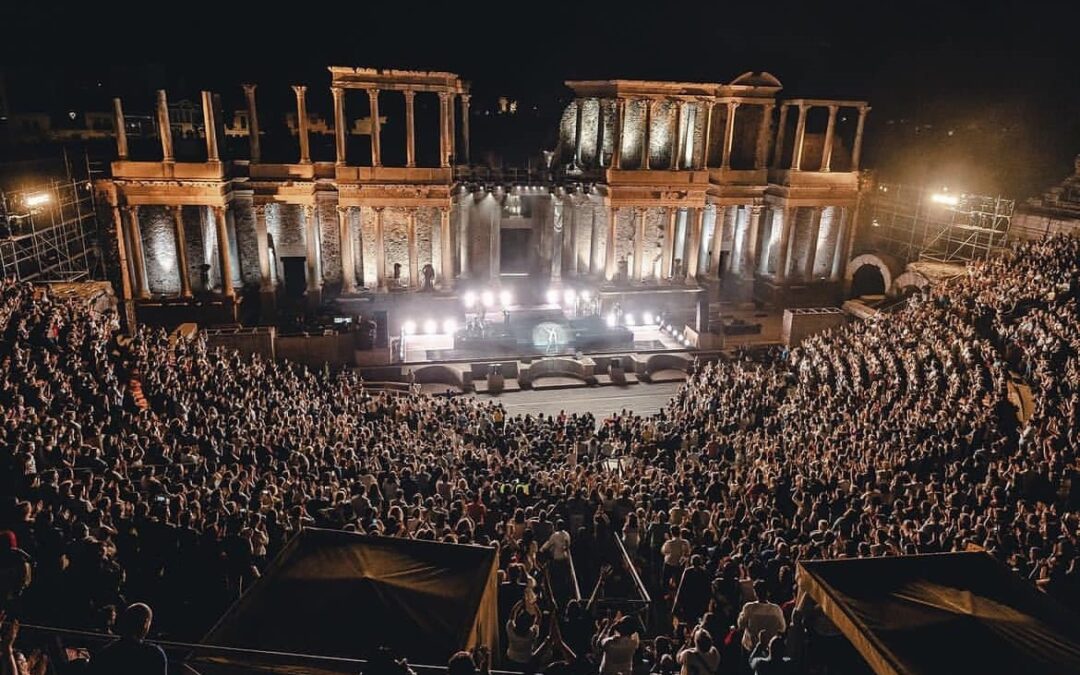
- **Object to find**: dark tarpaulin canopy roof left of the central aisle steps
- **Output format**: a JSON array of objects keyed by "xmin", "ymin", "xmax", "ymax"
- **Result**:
[{"xmin": 203, "ymin": 529, "xmax": 499, "ymax": 664}]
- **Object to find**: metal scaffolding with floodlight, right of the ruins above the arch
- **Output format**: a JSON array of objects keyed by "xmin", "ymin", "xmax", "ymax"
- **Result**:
[{"xmin": 864, "ymin": 184, "xmax": 1015, "ymax": 262}]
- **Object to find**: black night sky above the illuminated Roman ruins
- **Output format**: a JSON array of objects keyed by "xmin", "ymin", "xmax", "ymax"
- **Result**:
[{"xmin": 0, "ymin": 0, "xmax": 1080, "ymax": 197}]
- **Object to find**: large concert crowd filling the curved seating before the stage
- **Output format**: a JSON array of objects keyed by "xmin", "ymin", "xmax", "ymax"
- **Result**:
[{"xmin": 0, "ymin": 237, "xmax": 1080, "ymax": 675}]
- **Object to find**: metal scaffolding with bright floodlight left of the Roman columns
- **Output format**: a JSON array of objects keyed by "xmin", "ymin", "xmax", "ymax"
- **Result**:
[{"xmin": 0, "ymin": 179, "xmax": 97, "ymax": 282}]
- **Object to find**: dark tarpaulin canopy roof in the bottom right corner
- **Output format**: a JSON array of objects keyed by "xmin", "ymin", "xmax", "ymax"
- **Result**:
[{"xmin": 798, "ymin": 553, "xmax": 1080, "ymax": 675}]
